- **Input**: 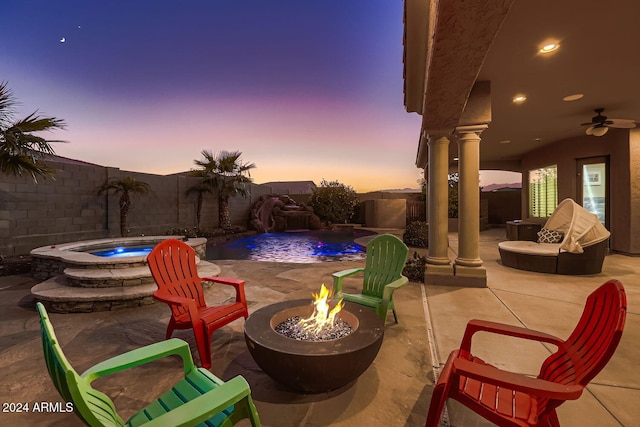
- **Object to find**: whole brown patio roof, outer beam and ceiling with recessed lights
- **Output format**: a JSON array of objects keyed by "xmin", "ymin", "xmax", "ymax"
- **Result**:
[{"xmin": 404, "ymin": 0, "xmax": 640, "ymax": 175}]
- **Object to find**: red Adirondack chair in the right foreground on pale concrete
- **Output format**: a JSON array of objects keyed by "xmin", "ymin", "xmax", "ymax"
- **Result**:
[{"xmin": 426, "ymin": 280, "xmax": 627, "ymax": 427}]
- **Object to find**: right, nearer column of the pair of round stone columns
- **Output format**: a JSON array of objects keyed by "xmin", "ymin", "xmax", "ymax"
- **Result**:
[{"xmin": 454, "ymin": 125, "xmax": 487, "ymax": 286}]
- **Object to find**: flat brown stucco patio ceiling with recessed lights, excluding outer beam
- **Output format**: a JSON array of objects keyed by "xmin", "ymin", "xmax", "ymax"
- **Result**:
[{"xmin": 476, "ymin": 0, "xmax": 640, "ymax": 171}]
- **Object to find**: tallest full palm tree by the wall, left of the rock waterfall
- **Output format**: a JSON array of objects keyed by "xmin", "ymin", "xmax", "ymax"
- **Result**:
[{"xmin": 191, "ymin": 150, "xmax": 256, "ymax": 230}]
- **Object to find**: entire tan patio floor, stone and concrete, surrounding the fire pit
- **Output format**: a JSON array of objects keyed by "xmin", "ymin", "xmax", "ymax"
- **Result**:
[{"xmin": 0, "ymin": 229, "xmax": 640, "ymax": 427}]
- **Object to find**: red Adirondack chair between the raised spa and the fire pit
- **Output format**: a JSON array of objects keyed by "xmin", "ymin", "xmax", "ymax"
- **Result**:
[{"xmin": 147, "ymin": 239, "xmax": 249, "ymax": 369}]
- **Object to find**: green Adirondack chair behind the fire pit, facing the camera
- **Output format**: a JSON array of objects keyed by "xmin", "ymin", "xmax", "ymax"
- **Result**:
[{"xmin": 333, "ymin": 234, "xmax": 409, "ymax": 324}]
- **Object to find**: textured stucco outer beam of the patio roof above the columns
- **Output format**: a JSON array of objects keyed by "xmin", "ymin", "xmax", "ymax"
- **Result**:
[{"xmin": 404, "ymin": 0, "xmax": 513, "ymax": 168}]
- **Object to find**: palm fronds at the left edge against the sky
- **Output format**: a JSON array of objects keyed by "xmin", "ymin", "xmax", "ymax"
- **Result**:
[{"xmin": 0, "ymin": 82, "xmax": 65, "ymax": 182}]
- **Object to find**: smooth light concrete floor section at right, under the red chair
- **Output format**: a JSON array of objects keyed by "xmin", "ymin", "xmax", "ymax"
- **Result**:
[{"xmin": 426, "ymin": 229, "xmax": 640, "ymax": 427}]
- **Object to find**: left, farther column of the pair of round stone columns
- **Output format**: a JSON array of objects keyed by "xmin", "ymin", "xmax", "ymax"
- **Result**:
[{"xmin": 426, "ymin": 136, "xmax": 453, "ymax": 275}]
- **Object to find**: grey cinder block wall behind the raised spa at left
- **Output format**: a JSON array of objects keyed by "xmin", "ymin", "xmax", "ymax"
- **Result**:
[{"xmin": 0, "ymin": 158, "xmax": 271, "ymax": 256}]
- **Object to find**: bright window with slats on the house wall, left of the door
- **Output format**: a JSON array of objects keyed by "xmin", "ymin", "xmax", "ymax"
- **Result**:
[{"xmin": 529, "ymin": 165, "xmax": 558, "ymax": 218}]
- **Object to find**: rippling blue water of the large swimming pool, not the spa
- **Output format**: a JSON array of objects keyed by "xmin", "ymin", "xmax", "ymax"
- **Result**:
[{"xmin": 207, "ymin": 230, "xmax": 373, "ymax": 263}]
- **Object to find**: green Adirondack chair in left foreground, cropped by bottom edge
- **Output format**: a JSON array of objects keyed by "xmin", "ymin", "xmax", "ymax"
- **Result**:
[{"xmin": 37, "ymin": 303, "xmax": 260, "ymax": 427}]
